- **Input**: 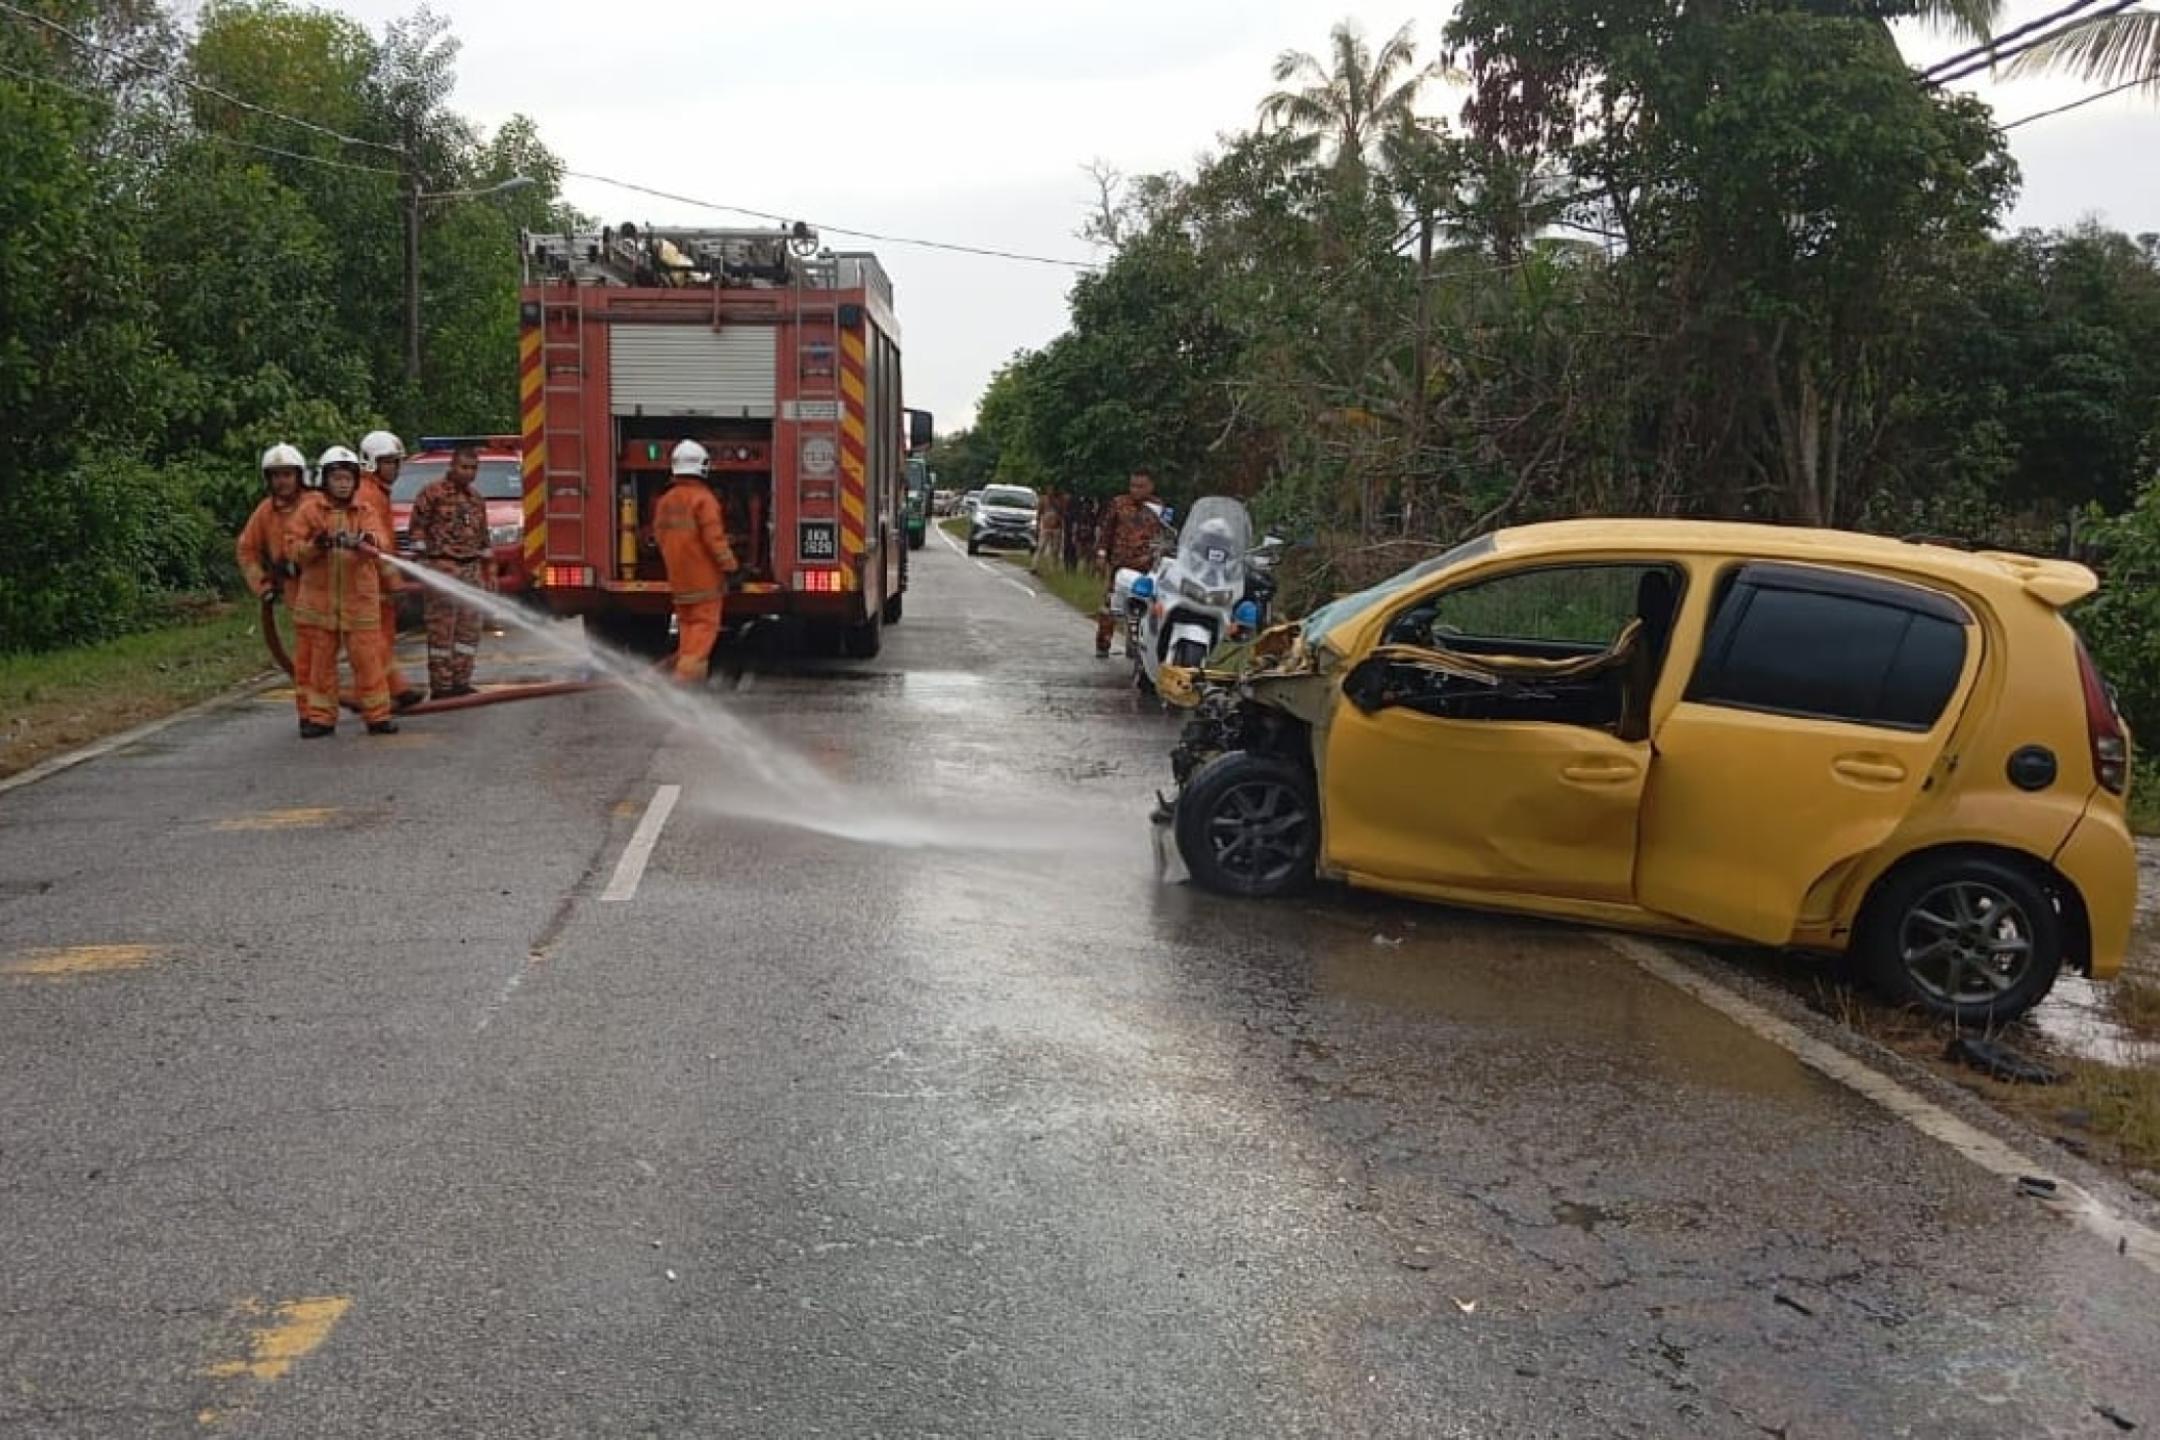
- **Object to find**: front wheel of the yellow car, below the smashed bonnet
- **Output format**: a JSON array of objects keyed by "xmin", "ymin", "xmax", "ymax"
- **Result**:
[{"xmin": 1177, "ymin": 749, "xmax": 1320, "ymax": 898}]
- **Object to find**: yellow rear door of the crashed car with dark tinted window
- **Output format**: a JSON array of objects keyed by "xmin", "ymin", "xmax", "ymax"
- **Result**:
[{"xmin": 1635, "ymin": 563, "xmax": 1983, "ymax": 943}]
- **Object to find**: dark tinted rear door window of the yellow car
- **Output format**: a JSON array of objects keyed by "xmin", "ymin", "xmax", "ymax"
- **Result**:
[{"xmin": 1687, "ymin": 566, "xmax": 1972, "ymax": 730}]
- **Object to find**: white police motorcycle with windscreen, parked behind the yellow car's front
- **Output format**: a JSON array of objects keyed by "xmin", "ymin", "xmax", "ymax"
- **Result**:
[{"xmin": 1110, "ymin": 494, "xmax": 1283, "ymax": 691}]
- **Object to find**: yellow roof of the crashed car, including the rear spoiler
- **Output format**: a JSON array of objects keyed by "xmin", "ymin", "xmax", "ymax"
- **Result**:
[{"xmin": 1493, "ymin": 518, "xmax": 2100, "ymax": 607}]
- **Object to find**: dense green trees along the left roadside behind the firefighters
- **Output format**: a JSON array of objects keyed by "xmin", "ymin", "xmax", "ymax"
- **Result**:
[{"xmin": 0, "ymin": 0, "xmax": 575, "ymax": 652}]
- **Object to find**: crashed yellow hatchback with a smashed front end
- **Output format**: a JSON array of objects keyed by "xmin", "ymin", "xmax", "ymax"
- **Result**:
[{"xmin": 1164, "ymin": 520, "xmax": 2136, "ymax": 1023}]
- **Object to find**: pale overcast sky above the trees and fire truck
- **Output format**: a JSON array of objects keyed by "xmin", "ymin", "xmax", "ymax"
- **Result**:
[{"xmin": 324, "ymin": 0, "xmax": 2160, "ymax": 427}]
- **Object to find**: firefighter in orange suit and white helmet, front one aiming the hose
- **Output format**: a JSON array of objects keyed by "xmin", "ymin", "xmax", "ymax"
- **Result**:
[{"xmin": 285, "ymin": 445, "xmax": 397, "ymax": 741}]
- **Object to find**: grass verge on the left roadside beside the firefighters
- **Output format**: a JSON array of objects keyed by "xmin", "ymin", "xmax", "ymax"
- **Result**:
[{"xmin": 0, "ymin": 604, "xmax": 270, "ymax": 775}]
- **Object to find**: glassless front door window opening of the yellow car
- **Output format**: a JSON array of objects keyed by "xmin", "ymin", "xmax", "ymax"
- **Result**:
[{"xmin": 1387, "ymin": 566, "xmax": 1672, "ymax": 650}]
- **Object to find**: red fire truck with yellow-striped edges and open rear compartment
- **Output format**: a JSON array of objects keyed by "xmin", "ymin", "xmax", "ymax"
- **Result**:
[{"xmin": 518, "ymin": 225, "xmax": 931, "ymax": 656}]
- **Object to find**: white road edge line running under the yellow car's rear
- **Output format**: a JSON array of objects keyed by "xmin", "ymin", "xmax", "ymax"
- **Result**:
[{"xmin": 1601, "ymin": 935, "xmax": 2160, "ymax": 1274}]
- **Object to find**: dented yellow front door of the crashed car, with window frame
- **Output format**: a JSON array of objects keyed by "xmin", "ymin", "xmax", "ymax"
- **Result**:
[{"xmin": 1322, "ymin": 561, "xmax": 1680, "ymax": 900}]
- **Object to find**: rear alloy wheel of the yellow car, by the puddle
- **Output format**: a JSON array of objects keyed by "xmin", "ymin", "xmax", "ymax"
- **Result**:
[{"xmin": 1858, "ymin": 855, "xmax": 2063, "ymax": 1025}]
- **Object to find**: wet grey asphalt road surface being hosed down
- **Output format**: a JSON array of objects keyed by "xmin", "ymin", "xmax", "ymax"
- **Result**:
[{"xmin": 0, "ymin": 538, "xmax": 2160, "ymax": 1438}]
